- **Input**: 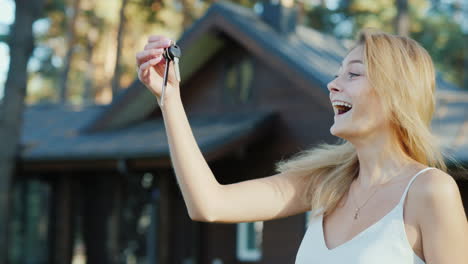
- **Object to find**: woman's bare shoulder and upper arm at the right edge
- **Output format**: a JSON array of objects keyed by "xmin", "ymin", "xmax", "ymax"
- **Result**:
[{"xmin": 412, "ymin": 169, "xmax": 468, "ymax": 264}]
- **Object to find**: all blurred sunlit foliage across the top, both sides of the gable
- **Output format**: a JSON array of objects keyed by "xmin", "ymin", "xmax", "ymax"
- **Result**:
[{"xmin": 21, "ymin": 0, "xmax": 468, "ymax": 102}]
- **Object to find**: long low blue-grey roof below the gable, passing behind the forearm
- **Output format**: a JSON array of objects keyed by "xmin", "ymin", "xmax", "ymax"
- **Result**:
[{"xmin": 21, "ymin": 105, "xmax": 275, "ymax": 162}]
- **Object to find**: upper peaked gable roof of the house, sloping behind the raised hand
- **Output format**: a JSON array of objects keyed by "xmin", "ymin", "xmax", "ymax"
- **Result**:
[{"xmin": 85, "ymin": 2, "xmax": 346, "ymax": 131}]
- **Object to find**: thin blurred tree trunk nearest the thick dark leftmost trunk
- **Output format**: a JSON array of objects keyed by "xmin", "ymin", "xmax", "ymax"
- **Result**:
[{"xmin": 59, "ymin": 0, "xmax": 81, "ymax": 103}]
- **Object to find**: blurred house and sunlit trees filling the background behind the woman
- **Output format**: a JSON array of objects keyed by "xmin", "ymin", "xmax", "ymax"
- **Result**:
[{"xmin": 0, "ymin": 0, "xmax": 468, "ymax": 264}]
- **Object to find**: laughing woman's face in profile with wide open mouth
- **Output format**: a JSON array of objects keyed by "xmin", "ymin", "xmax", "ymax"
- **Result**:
[{"xmin": 327, "ymin": 45, "xmax": 389, "ymax": 141}]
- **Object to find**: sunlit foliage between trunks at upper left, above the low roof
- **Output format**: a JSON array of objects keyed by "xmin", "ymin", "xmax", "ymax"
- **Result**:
[{"xmin": 27, "ymin": 0, "xmax": 185, "ymax": 103}]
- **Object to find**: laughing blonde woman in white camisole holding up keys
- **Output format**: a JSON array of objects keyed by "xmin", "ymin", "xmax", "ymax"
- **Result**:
[{"xmin": 136, "ymin": 31, "xmax": 468, "ymax": 264}]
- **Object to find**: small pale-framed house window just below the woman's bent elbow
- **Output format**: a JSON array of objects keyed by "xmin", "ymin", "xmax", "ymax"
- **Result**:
[{"xmin": 237, "ymin": 222, "xmax": 263, "ymax": 261}]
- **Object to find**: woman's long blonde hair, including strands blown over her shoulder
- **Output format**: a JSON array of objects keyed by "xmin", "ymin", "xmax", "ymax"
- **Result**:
[{"xmin": 276, "ymin": 29, "xmax": 447, "ymax": 219}]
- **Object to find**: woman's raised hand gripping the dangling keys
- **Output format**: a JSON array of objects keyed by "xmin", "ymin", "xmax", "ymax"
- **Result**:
[{"xmin": 136, "ymin": 36, "xmax": 179, "ymax": 104}]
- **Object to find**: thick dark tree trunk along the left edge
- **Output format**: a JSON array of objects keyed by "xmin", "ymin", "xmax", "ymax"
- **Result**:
[{"xmin": 0, "ymin": 0, "xmax": 43, "ymax": 263}]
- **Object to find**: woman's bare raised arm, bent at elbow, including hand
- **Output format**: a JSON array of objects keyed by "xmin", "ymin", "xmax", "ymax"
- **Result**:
[{"xmin": 137, "ymin": 36, "xmax": 309, "ymax": 223}]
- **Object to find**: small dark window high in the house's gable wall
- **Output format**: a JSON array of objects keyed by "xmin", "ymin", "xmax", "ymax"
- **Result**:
[{"xmin": 224, "ymin": 58, "xmax": 254, "ymax": 103}]
